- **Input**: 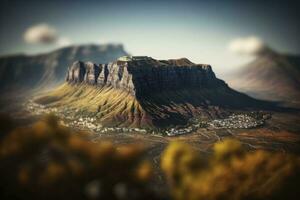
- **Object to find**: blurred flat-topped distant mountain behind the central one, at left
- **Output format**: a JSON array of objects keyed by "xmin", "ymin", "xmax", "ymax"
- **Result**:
[{"xmin": 0, "ymin": 44, "xmax": 128, "ymax": 92}]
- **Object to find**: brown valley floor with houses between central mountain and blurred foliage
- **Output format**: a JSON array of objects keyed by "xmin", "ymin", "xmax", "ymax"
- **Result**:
[{"xmin": 0, "ymin": 97, "xmax": 300, "ymax": 153}]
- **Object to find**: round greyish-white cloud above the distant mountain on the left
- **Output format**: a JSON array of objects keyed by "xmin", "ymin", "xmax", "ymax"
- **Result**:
[{"xmin": 24, "ymin": 23, "xmax": 57, "ymax": 44}]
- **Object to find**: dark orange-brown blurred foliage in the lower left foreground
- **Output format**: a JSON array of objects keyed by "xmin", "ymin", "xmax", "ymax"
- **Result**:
[{"xmin": 0, "ymin": 116, "xmax": 158, "ymax": 199}]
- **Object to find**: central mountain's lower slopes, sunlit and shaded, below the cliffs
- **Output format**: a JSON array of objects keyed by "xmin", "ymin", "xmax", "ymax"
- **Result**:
[{"xmin": 35, "ymin": 83, "xmax": 265, "ymax": 128}]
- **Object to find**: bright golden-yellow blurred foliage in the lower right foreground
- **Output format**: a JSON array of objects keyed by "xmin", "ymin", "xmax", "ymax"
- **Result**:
[{"xmin": 161, "ymin": 139, "xmax": 300, "ymax": 200}]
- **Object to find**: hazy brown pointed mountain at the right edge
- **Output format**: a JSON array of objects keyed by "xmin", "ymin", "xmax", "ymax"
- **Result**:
[{"xmin": 226, "ymin": 50, "xmax": 300, "ymax": 105}]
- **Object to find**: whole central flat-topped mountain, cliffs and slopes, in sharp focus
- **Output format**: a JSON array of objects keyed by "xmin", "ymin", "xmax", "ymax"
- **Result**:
[{"xmin": 35, "ymin": 57, "xmax": 269, "ymax": 127}]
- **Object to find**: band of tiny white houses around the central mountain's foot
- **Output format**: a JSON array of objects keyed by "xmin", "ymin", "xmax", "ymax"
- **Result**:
[{"xmin": 26, "ymin": 101, "xmax": 266, "ymax": 136}]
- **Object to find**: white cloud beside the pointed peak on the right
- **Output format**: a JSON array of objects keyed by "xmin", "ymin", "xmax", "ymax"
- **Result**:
[{"xmin": 228, "ymin": 36, "xmax": 266, "ymax": 55}]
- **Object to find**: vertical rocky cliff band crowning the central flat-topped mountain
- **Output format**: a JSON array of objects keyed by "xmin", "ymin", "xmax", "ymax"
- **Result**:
[{"xmin": 66, "ymin": 58, "xmax": 227, "ymax": 96}]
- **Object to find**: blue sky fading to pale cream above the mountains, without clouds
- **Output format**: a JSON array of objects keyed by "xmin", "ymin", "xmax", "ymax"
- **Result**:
[{"xmin": 0, "ymin": 0, "xmax": 300, "ymax": 72}]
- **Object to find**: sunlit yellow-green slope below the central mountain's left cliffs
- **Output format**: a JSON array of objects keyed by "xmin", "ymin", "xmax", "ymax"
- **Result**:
[{"xmin": 35, "ymin": 83, "xmax": 151, "ymax": 127}]
